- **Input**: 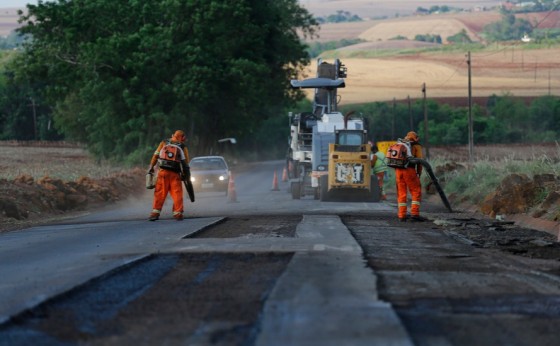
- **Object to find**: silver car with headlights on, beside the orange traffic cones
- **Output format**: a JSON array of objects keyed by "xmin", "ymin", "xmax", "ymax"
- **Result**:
[{"xmin": 189, "ymin": 156, "xmax": 230, "ymax": 196}]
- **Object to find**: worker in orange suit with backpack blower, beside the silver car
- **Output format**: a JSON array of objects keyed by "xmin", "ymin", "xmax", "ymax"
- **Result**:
[{"xmin": 148, "ymin": 130, "xmax": 191, "ymax": 221}]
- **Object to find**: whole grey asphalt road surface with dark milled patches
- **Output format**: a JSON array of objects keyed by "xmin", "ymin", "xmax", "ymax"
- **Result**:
[{"xmin": 0, "ymin": 162, "xmax": 560, "ymax": 345}]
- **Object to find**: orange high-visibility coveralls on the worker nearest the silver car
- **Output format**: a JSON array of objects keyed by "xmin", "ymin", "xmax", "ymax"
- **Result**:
[{"xmin": 150, "ymin": 133, "xmax": 190, "ymax": 219}]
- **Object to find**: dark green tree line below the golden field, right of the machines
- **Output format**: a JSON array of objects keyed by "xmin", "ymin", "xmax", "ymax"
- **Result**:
[{"xmin": 341, "ymin": 94, "xmax": 560, "ymax": 145}]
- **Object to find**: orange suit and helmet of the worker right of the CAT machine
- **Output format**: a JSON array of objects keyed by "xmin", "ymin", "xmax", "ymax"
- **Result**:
[{"xmin": 395, "ymin": 131, "xmax": 425, "ymax": 221}]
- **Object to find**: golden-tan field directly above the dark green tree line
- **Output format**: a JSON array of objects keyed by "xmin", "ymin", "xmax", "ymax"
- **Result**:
[{"xmin": 316, "ymin": 47, "xmax": 560, "ymax": 104}]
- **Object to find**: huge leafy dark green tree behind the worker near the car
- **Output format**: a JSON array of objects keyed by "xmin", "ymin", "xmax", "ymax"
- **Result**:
[{"xmin": 12, "ymin": 0, "xmax": 316, "ymax": 162}]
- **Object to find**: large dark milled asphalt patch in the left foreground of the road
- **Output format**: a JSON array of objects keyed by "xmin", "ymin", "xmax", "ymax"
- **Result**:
[{"xmin": 0, "ymin": 253, "xmax": 292, "ymax": 345}]
